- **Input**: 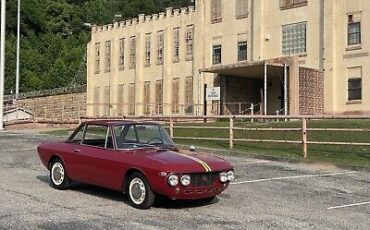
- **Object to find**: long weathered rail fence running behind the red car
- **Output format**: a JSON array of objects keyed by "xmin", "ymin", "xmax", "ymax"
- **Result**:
[{"xmin": 6, "ymin": 115, "xmax": 370, "ymax": 158}]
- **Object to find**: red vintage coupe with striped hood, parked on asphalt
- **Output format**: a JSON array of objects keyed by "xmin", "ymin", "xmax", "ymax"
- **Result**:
[{"xmin": 37, "ymin": 120, "xmax": 234, "ymax": 209}]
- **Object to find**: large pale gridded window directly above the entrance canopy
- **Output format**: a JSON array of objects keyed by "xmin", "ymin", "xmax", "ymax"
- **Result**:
[{"xmin": 282, "ymin": 22, "xmax": 307, "ymax": 55}]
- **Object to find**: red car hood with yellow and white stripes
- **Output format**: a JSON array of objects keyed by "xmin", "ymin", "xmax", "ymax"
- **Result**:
[{"xmin": 138, "ymin": 150, "xmax": 232, "ymax": 173}]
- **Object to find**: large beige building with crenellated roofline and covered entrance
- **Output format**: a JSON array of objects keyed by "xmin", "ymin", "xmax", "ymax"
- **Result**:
[{"xmin": 87, "ymin": 0, "xmax": 370, "ymax": 117}]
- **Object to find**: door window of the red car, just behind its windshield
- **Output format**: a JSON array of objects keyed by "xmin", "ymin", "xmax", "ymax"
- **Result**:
[{"xmin": 82, "ymin": 125, "xmax": 109, "ymax": 148}]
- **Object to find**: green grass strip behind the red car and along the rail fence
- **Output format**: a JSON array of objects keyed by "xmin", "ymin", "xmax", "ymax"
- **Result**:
[{"xmin": 40, "ymin": 119, "xmax": 370, "ymax": 169}]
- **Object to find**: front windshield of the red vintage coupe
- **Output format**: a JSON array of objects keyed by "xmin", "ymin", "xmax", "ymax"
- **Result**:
[{"xmin": 114, "ymin": 124, "xmax": 174, "ymax": 149}]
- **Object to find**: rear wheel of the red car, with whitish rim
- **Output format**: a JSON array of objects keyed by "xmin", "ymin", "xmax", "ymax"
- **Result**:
[{"xmin": 50, "ymin": 158, "xmax": 70, "ymax": 190}]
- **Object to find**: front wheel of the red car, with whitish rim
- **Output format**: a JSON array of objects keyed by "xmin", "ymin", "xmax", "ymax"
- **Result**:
[{"xmin": 126, "ymin": 173, "xmax": 155, "ymax": 209}]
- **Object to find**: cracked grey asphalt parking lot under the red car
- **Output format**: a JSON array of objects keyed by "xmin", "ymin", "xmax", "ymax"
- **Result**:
[{"xmin": 0, "ymin": 132, "xmax": 370, "ymax": 230}]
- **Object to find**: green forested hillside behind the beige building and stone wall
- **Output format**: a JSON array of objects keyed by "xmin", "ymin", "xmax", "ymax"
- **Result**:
[{"xmin": 5, "ymin": 0, "xmax": 191, "ymax": 94}]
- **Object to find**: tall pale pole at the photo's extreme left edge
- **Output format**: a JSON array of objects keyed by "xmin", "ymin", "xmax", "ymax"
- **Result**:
[{"xmin": 0, "ymin": 0, "xmax": 6, "ymax": 130}]
